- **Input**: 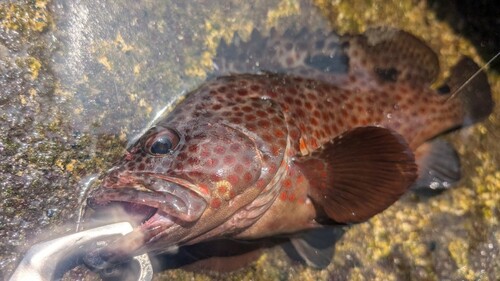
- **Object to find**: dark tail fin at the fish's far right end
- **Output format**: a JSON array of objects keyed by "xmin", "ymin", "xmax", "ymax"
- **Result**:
[{"xmin": 447, "ymin": 57, "xmax": 494, "ymax": 126}]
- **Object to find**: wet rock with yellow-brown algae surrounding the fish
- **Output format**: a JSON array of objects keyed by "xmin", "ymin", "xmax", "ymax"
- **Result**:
[{"xmin": 0, "ymin": 0, "xmax": 500, "ymax": 280}]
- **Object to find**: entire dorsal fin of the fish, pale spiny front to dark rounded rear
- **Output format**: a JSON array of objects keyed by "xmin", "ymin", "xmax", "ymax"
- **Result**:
[{"xmin": 212, "ymin": 28, "xmax": 439, "ymax": 87}]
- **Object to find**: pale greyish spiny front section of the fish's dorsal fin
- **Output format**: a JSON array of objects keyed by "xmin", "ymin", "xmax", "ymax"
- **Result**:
[{"xmin": 211, "ymin": 28, "xmax": 349, "ymax": 82}]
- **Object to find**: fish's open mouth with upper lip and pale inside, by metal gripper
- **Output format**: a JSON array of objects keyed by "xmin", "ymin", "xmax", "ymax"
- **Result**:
[{"xmin": 87, "ymin": 181, "xmax": 207, "ymax": 225}]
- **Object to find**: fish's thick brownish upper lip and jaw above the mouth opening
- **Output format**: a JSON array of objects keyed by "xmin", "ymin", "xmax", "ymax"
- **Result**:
[{"xmin": 87, "ymin": 177, "xmax": 207, "ymax": 224}]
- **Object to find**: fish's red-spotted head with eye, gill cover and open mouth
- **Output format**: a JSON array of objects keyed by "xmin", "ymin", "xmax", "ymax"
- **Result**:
[{"xmin": 87, "ymin": 119, "xmax": 262, "ymax": 254}]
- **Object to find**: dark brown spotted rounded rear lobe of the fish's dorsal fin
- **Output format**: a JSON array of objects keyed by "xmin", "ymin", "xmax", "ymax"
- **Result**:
[{"xmin": 349, "ymin": 27, "xmax": 439, "ymax": 85}]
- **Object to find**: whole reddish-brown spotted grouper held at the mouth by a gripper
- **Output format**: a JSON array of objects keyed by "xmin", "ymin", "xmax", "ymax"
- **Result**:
[{"xmin": 87, "ymin": 28, "xmax": 493, "ymax": 267}]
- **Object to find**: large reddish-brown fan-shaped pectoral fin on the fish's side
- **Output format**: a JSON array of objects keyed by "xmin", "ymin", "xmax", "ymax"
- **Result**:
[{"xmin": 296, "ymin": 127, "xmax": 417, "ymax": 223}]
